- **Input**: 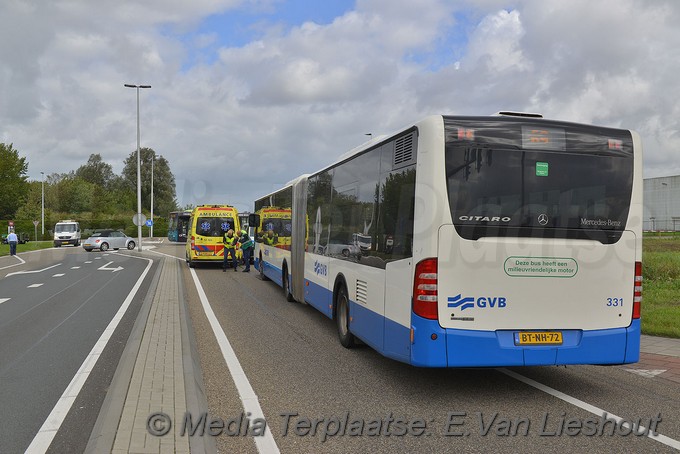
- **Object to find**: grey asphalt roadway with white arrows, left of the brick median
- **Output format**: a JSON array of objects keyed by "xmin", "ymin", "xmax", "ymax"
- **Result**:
[{"xmin": 0, "ymin": 247, "xmax": 157, "ymax": 453}]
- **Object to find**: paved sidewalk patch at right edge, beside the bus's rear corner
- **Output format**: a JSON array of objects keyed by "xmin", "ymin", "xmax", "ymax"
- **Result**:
[{"xmin": 622, "ymin": 334, "xmax": 680, "ymax": 383}]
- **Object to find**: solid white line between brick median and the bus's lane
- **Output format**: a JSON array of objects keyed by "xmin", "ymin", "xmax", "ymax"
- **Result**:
[{"xmin": 189, "ymin": 268, "xmax": 280, "ymax": 453}]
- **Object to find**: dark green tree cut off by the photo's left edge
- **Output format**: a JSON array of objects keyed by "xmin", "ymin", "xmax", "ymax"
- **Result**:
[{"xmin": 0, "ymin": 143, "xmax": 28, "ymax": 219}]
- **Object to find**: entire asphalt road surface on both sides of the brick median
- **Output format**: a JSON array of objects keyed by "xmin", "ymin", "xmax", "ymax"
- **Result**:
[{"xmin": 0, "ymin": 243, "xmax": 680, "ymax": 453}]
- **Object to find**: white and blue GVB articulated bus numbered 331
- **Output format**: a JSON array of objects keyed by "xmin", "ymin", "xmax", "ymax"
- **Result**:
[{"xmin": 255, "ymin": 112, "xmax": 642, "ymax": 367}]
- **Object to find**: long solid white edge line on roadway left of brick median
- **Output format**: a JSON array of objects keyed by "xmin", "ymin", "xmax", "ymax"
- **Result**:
[{"xmin": 26, "ymin": 256, "xmax": 153, "ymax": 453}]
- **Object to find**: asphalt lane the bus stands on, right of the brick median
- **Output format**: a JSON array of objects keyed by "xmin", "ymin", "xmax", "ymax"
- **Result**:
[{"xmin": 150, "ymin": 241, "xmax": 680, "ymax": 453}]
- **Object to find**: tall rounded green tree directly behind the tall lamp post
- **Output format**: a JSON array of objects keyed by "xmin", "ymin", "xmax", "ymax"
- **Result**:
[{"xmin": 123, "ymin": 148, "xmax": 177, "ymax": 216}]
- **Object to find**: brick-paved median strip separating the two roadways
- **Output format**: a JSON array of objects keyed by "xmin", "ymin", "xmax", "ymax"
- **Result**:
[{"xmin": 112, "ymin": 259, "xmax": 190, "ymax": 454}]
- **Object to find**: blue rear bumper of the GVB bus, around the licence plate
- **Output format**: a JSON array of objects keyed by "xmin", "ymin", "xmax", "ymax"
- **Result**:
[{"xmin": 411, "ymin": 317, "xmax": 640, "ymax": 367}]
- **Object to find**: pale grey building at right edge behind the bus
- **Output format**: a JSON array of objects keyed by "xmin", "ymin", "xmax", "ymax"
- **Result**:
[{"xmin": 642, "ymin": 175, "xmax": 680, "ymax": 232}]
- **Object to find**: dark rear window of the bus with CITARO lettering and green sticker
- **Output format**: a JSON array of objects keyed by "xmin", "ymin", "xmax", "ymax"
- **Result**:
[{"xmin": 445, "ymin": 117, "xmax": 633, "ymax": 243}]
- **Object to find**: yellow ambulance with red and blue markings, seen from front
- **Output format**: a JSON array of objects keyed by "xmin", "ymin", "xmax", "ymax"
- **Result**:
[{"xmin": 186, "ymin": 205, "xmax": 241, "ymax": 268}]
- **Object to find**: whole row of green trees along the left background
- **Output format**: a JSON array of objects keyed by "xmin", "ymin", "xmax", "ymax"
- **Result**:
[{"xmin": 0, "ymin": 143, "xmax": 178, "ymax": 238}]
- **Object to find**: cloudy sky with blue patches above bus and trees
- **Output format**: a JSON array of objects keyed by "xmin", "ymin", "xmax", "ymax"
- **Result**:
[{"xmin": 0, "ymin": 0, "xmax": 680, "ymax": 211}]
